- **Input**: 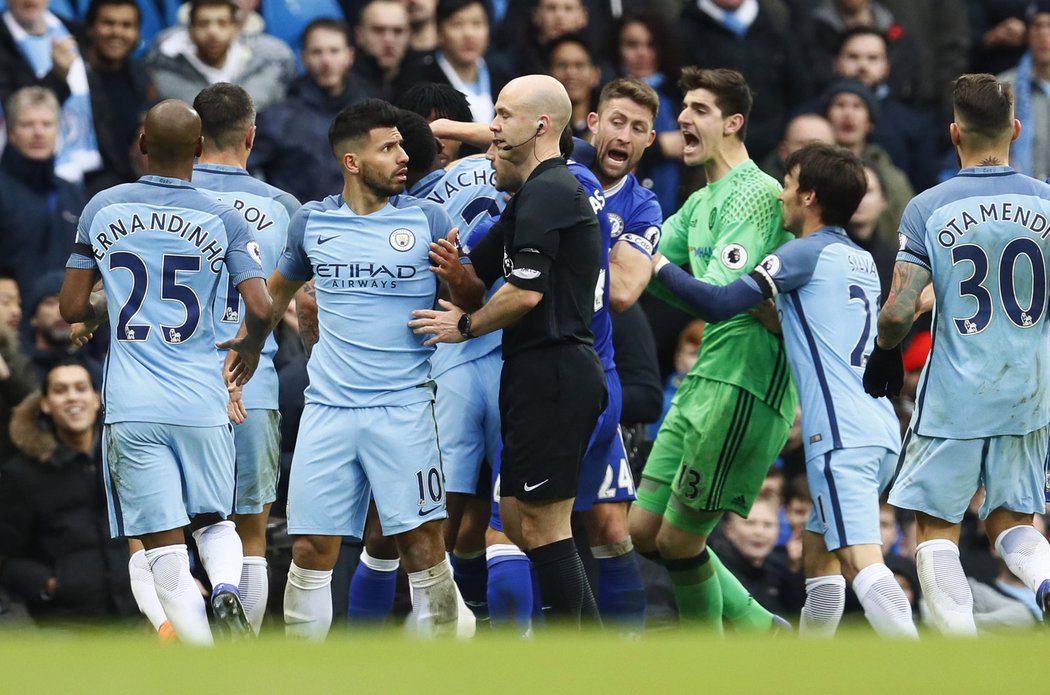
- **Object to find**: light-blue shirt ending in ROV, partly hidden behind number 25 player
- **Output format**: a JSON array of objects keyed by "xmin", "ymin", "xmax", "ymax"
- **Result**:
[{"xmin": 192, "ymin": 164, "xmax": 299, "ymax": 410}]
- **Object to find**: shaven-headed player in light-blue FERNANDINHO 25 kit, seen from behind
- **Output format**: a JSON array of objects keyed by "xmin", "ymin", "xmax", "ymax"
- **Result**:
[{"xmin": 60, "ymin": 100, "xmax": 270, "ymax": 644}]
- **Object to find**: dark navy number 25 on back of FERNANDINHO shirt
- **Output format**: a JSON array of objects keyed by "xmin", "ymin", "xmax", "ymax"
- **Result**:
[{"xmin": 109, "ymin": 251, "xmax": 201, "ymax": 343}]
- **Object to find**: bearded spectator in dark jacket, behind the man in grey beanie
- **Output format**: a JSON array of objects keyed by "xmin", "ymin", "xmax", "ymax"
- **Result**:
[{"xmin": 832, "ymin": 26, "xmax": 940, "ymax": 191}]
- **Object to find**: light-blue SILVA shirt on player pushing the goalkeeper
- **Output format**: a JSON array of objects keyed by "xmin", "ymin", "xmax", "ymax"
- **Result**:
[{"xmin": 741, "ymin": 227, "xmax": 901, "ymax": 460}]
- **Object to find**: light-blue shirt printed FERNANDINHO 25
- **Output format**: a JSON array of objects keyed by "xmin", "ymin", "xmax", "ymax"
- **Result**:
[{"xmin": 66, "ymin": 176, "xmax": 264, "ymax": 427}]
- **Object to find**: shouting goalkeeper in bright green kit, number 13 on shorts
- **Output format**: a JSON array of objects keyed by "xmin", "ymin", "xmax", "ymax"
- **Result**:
[{"xmin": 630, "ymin": 67, "xmax": 798, "ymax": 631}]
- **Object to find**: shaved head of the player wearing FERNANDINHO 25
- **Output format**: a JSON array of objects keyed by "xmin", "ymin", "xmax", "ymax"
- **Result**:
[{"xmin": 139, "ymin": 99, "xmax": 203, "ymax": 181}]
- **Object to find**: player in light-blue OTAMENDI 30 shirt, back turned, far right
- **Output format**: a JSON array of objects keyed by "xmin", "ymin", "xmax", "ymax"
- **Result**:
[{"xmin": 864, "ymin": 75, "xmax": 1050, "ymax": 635}]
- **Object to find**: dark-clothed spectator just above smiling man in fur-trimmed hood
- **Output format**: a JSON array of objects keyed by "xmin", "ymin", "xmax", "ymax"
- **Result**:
[{"xmin": 25, "ymin": 270, "xmax": 102, "ymax": 383}]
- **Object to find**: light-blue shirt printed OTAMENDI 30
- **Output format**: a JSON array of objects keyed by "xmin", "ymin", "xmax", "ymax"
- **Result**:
[{"xmin": 897, "ymin": 167, "xmax": 1050, "ymax": 439}]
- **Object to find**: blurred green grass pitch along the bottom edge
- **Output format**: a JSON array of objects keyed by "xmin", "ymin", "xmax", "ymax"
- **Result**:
[{"xmin": 0, "ymin": 630, "xmax": 1050, "ymax": 695}]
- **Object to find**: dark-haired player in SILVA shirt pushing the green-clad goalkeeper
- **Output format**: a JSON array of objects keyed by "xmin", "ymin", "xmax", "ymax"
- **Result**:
[{"xmin": 654, "ymin": 145, "xmax": 918, "ymax": 637}]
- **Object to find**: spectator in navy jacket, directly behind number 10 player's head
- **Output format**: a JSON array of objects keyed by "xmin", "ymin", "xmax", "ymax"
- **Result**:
[{"xmin": 248, "ymin": 19, "xmax": 372, "ymax": 203}]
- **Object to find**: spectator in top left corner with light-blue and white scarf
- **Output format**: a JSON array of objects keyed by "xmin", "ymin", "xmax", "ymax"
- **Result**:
[{"xmin": 0, "ymin": 0, "xmax": 102, "ymax": 183}]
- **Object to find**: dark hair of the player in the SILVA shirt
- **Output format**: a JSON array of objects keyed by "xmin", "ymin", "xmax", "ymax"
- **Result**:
[{"xmin": 784, "ymin": 143, "xmax": 867, "ymax": 228}]
